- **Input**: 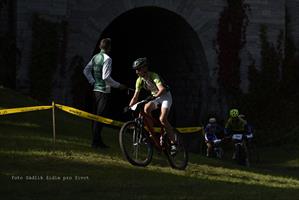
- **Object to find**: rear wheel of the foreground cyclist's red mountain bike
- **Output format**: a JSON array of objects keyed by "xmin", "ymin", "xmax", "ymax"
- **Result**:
[{"xmin": 164, "ymin": 131, "xmax": 189, "ymax": 170}]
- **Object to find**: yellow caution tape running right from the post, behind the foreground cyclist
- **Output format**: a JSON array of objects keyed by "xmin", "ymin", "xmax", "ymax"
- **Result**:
[{"xmin": 55, "ymin": 104, "xmax": 202, "ymax": 133}]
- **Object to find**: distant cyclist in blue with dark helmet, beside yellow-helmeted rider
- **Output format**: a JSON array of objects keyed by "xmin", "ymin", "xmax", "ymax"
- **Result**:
[{"xmin": 204, "ymin": 117, "xmax": 221, "ymax": 157}]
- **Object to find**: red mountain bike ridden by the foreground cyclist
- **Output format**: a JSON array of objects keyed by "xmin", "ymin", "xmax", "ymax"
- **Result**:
[{"xmin": 119, "ymin": 99, "xmax": 188, "ymax": 170}]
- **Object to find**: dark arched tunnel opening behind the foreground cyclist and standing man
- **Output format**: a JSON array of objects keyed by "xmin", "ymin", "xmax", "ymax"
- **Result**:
[{"xmin": 94, "ymin": 7, "xmax": 208, "ymax": 126}]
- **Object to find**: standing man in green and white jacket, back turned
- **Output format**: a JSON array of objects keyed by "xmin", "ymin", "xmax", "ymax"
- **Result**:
[{"xmin": 83, "ymin": 38, "xmax": 127, "ymax": 148}]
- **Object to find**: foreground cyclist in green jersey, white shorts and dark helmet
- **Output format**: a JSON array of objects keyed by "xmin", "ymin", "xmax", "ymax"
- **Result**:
[{"xmin": 129, "ymin": 57, "xmax": 176, "ymax": 154}]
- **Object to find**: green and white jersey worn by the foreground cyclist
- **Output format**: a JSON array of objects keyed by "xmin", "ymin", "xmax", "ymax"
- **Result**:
[{"xmin": 135, "ymin": 72, "xmax": 168, "ymax": 95}]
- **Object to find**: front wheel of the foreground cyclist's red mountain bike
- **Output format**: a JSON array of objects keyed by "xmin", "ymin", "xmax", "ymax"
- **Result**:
[{"xmin": 119, "ymin": 121, "xmax": 153, "ymax": 166}]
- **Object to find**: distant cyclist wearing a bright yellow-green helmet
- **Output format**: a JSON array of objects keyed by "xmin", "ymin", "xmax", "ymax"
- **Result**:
[{"xmin": 224, "ymin": 109, "xmax": 248, "ymax": 162}]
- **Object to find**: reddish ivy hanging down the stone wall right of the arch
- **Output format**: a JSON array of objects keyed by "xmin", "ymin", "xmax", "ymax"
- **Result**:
[{"xmin": 217, "ymin": 0, "xmax": 250, "ymax": 103}]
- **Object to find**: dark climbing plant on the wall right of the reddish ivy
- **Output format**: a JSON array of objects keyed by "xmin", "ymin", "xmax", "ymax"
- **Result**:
[{"xmin": 245, "ymin": 25, "xmax": 283, "ymax": 130}]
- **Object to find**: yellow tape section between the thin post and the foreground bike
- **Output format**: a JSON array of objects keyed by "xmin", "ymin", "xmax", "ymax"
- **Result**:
[{"xmin": 55, "ymin": 104, "xmax": 123, "ymax": 127}]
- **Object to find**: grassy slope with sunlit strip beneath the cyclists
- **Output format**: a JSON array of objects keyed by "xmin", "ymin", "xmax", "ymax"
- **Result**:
[{"xmin": 0, "ymin": 88, "xmax": 299, "ymax": 200}]
